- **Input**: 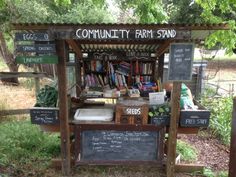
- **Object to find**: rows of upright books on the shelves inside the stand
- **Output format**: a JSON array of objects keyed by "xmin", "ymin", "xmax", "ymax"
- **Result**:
[{"xmin": 85, "ymin": 60, "xmax": 152, "ymax": 88}]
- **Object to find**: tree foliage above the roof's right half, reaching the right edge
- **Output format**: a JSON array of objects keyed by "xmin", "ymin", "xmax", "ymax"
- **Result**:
[{"xmin": 119, "ymin": 0, "xmax": 236, "ymax": 54}]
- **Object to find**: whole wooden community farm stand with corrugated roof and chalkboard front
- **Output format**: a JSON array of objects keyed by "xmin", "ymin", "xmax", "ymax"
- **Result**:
[{"xmin": 12, "ymin": 24, "xmax": 228, "ymax": 177}]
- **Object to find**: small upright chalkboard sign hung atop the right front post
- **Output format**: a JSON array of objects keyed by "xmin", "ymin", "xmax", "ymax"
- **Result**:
[{"xmin": 168, "ymin": 43, "xmax": 194, "ymax": 81}]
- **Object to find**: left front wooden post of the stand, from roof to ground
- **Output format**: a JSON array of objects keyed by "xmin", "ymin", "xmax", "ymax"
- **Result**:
[{"xmin": 56, "ymin": 40, "xmax": 71, "ymax": 176}]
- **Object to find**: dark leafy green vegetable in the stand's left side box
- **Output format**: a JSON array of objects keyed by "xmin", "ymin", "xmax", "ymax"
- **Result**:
[{"xmin": 35, "ymin": 85, "xmax": 58, "ymax": 107}]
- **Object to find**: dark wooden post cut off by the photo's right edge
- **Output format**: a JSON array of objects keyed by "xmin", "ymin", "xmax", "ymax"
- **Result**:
[{"xmin": 229, "ymin": 97, "xmax": 236, "ymax": 177}]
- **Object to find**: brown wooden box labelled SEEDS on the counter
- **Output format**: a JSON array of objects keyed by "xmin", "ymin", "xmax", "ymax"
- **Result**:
[{"xmin": 115, "ymin": 100, "xmax": 148, "ymax": 125}]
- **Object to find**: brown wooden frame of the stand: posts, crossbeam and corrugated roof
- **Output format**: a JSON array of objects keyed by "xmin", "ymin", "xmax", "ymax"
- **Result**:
[{"xmin": 12, "ymin": 24, "xmax": 228, "ymax": 177}]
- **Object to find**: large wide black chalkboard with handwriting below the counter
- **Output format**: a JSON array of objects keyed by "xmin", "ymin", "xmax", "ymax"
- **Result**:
[{"xmin": 81, "ymin": 130, "xmax": 159, "ymax": 161}]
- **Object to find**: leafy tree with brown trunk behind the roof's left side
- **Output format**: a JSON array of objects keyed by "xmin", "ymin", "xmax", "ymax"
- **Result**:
[{"xmin": 0, "ymin": 0, "xmax": 113, "ymax": 83}]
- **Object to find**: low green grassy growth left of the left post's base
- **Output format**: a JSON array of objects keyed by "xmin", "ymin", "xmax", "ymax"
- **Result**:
[{"xmin": 0, "ymin": 121, "xmax": 60, "ymax": 176}]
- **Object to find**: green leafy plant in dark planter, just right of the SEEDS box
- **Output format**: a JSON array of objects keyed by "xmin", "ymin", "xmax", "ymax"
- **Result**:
[{"xmin": 148, "ymin": 102, "xmax": 171, "ymax": 126}]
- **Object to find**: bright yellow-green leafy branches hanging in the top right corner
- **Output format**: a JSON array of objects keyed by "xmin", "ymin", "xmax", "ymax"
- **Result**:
[{"xmin": 196, "ymin": 0, "xmax": 236, "ymax": 54}]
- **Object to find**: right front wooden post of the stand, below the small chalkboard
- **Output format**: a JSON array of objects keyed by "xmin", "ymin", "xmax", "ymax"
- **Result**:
[{"xmin": 166, "ymin": 82, "xmax": 181, "ymax": 177}]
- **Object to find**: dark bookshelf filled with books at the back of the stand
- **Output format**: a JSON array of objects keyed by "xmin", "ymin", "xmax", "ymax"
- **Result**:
[{"xmin": 83, "ymin": 53, "xmax": 156, "ymax": 97}]
